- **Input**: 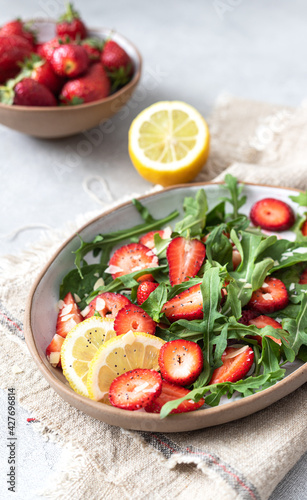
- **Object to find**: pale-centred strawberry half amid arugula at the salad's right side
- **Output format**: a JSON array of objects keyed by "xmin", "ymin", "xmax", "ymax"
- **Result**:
[{"xmin": 248, "ymin": 277, "xmax": 289, "ymax": 314}]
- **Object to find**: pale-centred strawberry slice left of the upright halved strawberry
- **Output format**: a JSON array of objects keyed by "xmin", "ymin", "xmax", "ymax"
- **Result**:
[{"xmin": 109, "ymin": 243, "xmax": 159, "ymax": 279}]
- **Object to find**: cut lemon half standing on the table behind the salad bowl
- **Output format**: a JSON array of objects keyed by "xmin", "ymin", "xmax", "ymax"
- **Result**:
[{"xmin": 129, "ymin": 101, "xmax": 210, "ymax": 186}]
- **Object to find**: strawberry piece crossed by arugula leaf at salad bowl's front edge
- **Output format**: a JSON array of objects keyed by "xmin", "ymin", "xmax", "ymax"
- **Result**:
[{"xmin": 145, "ymin": 380, "xmax": 205, "ymax": 413}]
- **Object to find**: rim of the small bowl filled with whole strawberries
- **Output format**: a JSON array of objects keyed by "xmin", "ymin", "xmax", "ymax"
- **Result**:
[{"xmin": 0, "ymin": 19, "xmax": 143, "ymax": 113}]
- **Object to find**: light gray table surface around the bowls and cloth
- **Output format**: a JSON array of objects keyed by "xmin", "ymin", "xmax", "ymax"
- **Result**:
[{"xmin": 0, "ymin": 0, "xmax": 307, "ymax": 500}]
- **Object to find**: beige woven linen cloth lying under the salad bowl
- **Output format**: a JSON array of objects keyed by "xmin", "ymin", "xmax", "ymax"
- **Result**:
[{"xmin": 0, "ymin": 96, "xmax": 307, "ymax": 500}]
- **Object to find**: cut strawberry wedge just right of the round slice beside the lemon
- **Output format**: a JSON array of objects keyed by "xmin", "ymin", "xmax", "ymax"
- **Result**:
[{"xmin": 209, "ymin": 346, "xmax": 254, "ymax": 385}]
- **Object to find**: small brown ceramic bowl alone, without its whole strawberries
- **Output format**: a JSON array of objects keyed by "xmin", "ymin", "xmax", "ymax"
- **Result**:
[{"xmin": 0, "ymin": 21, "xmax": 142, "ymax": 139}]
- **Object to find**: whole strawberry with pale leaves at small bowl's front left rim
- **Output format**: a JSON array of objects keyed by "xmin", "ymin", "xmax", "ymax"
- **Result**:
[{"xmin": 0, "ymin": 78, "xmax": 57, "ymax": 106}]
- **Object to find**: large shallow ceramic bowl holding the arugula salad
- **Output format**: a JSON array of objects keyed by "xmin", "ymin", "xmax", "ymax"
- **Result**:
[{"xmin": 25, "ymin": 184, "xmax": 307, "ymax": 432}]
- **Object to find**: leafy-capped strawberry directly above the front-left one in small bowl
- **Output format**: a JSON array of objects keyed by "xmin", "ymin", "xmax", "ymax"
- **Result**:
[{"xmin": 21, "ymin": 54, "xmax": 64, "ymax": 94}]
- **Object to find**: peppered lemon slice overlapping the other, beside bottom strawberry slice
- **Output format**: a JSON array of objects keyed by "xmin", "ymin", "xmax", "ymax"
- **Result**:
[{"xmin": 87, "ymin": 331, "xmax": 164, "ymax": 403}]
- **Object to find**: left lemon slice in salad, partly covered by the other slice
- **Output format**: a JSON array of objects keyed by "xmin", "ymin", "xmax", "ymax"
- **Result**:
[{"xmin": 61, "ymin": 316, "xmax": 116, "ymax": 396}]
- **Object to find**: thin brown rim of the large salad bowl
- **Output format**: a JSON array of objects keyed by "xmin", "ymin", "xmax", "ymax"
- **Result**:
[{"xmin": 24, "ymin": 182, "xmax": 307, "ymax": 432}]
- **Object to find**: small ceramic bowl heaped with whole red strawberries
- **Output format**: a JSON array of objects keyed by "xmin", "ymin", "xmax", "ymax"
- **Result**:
[{"xmin": 0, "ymin": 4, "xmax": 142, "ymax": 138}]
